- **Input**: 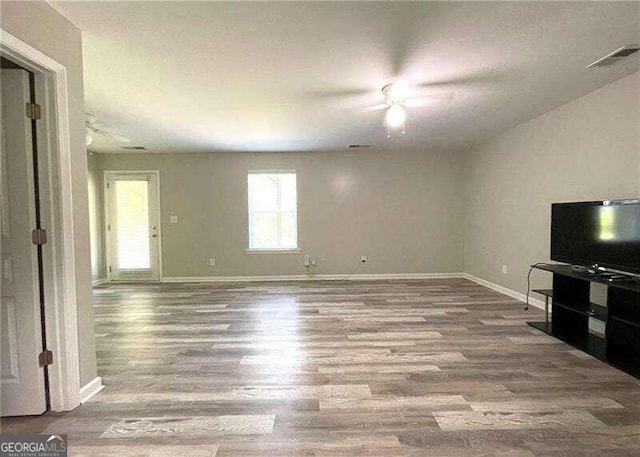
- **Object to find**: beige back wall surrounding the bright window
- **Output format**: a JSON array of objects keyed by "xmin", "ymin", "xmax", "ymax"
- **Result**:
[{"xmin": 100, "ymin": 149, "xmax": 463, "ymax": 277}]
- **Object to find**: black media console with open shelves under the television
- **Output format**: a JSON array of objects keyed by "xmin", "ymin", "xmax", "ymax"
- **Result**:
[{"xmin": 528, "ymin": 265, "xmax": 640, "ymax": 378}]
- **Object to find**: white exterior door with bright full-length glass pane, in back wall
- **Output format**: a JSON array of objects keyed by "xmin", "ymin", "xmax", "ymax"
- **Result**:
[{"xmin": 105, "ymin": 171, "xmax": 160, "ymax": 281}]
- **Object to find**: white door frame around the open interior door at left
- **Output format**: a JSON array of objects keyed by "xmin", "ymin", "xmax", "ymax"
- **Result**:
[{"xmin": 0, "ymin": 28, "xmax": 81, "ymax": 411}]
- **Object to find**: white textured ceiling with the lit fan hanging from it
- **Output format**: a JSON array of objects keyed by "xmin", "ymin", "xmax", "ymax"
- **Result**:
[{"xmin": 54, "ymin": 1, "xmax": 640, "ymax": 152}]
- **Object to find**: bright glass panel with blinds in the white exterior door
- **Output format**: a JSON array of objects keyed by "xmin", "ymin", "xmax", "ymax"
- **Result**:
[{"xmin": 115, "ymin": 181, "xmax": 151, "ymax": 270}]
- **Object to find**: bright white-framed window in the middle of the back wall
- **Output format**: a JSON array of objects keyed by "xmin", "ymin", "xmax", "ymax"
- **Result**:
[{"xmin": 247, "ymin": 171, "xmax": 298, "ymax": 250}]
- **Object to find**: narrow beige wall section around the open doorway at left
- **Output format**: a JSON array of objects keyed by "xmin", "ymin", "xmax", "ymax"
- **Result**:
[{"xmin": 0, "ymin": 1, "xmax": 96, "ymax": 385}]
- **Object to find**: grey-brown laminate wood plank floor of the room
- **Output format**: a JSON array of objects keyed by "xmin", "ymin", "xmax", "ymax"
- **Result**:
[{"xmin": 2, "ymin": 279, "xmax": 640, "ymax": 457}]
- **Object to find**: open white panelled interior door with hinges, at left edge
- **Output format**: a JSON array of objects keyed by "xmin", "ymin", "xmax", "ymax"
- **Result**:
[{"xmin": 0, "ymin": 69, "xmax": 47, "ymax": 416}]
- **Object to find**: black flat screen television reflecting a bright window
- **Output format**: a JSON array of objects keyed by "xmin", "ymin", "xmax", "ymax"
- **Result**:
[{"xmin": 551, "ymin": 199, "xmax": 640, "ymax": 274}]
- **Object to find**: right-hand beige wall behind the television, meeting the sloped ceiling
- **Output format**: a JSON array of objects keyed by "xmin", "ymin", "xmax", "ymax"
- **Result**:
[{"xmin": 464, "ymin": 70, "xmax": 640, "ymax": 292}]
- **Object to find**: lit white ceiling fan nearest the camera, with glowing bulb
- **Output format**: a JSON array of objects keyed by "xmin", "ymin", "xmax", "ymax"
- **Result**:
[{"xmin": 361, "ymin": 80, "xmax": 453, "ymax": 138}]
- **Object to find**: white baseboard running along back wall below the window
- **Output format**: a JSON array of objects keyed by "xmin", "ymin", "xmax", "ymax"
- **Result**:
[{"xmin": 162, "ymin": 273, "xmax": 465, "ymax": 282}]
